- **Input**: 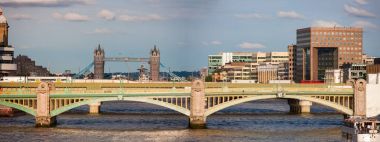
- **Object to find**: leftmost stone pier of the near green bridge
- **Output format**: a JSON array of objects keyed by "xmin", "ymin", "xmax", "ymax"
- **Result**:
[{"xmin": 35, "ymin": 82, "xmax": 57, "ymax": 127}]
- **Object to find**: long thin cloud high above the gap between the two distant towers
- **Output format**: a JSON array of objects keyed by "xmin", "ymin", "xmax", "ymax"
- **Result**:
[{"xmin": 117, "ymin": 14, "xmax": 165, "ymax": 22}]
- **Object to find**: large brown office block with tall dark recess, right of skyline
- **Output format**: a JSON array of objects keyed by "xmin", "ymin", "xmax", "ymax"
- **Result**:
[{"xmin": 293, "ymin": 27, "xmax": 363, "ymax": 82}]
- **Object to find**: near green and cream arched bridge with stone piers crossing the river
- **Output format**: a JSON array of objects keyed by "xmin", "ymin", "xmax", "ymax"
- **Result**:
[{"xmin": 0, "ymin": 80, "xmax": 366, "ymax": 128}]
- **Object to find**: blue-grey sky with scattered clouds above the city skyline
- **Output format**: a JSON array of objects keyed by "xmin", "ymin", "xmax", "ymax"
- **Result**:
[{"xmin": 0, "ymin": 0, "xmax": 380, "ymax": 72}]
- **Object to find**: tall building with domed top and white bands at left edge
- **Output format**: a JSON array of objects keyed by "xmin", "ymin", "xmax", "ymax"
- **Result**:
[{"xmin": 0, "ymin": 8, "xmax": 17, "ymax": 76}]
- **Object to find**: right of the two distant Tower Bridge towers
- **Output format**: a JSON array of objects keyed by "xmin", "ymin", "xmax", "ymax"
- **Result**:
[{"xmin": 149, "ymin": 45, "xmax": 160, "ymax": 81}]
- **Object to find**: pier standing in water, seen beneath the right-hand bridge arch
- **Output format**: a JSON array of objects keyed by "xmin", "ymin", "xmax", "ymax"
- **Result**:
[{"xmin": 288, "ymin": 99, "xmax": 312, "ymax": 114}]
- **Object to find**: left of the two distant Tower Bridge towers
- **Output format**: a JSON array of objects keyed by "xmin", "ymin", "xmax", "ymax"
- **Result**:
[{"xmin": 94, "ymin": 44, "xmax": 105, "ymax": 79}]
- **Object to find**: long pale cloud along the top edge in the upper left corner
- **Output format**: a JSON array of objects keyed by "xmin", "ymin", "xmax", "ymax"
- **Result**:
[{"xmin": 0, "ymin": 0, "xmax": 95, "ymax": 7}]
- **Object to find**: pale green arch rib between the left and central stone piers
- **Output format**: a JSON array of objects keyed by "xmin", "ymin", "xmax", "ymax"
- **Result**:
[{"xmin": 50, "ymin": 97, "xmax": 190, "ymax": 116}]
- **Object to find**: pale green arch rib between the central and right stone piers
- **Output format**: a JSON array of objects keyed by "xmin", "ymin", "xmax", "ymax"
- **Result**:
[{"xmin": 205, "ymin": 95, "xmax": 353, "ymax": 117}]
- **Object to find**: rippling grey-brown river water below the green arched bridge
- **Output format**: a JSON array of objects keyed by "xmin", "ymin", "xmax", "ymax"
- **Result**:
[{"xmin": 0, "ymin": 100, "xmax": 356, "ymax": 142}]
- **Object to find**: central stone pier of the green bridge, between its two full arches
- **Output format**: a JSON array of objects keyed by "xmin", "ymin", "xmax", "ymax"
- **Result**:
[{"xmin": 189, "ymin": 80, "xmax": 206, "ymax": 129}]
